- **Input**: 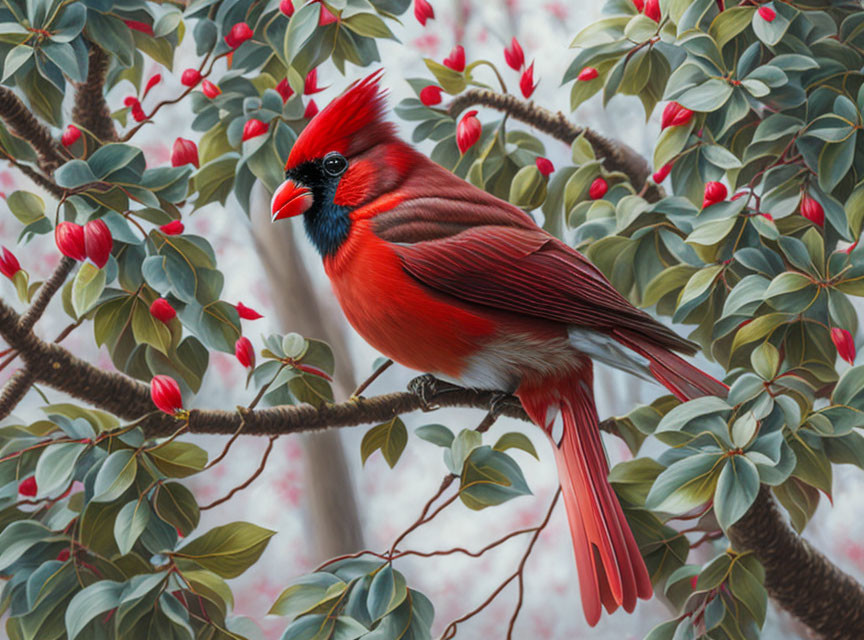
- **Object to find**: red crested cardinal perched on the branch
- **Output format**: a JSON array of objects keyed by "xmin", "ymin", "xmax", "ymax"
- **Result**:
[{"xmin": 272, "ymin": 72, "xmax": 726, "ymax": 625}]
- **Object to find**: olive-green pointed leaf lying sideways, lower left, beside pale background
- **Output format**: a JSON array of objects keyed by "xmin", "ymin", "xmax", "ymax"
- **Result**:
[{"xmin": 174, "ymin": 522, "xmax": 276, "ymax": 578}]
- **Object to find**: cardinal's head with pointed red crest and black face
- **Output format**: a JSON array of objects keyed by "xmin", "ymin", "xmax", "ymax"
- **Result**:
[{"xmin": 271, "ymin": 70, "xmax": 415, "ymax": 256}]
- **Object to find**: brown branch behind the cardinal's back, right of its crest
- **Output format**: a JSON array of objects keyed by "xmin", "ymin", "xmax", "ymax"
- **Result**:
[{"xmin": 447, "ymin": 89, "xmax": 666, "ymax": 202}]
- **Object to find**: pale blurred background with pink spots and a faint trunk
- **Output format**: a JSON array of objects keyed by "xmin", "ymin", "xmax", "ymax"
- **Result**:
[{"xmin": 0, "ymin": 0, "xmax": 864, "ymax": 640}]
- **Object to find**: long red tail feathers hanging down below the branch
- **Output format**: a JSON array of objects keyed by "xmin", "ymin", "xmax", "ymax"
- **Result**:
[{"xmin": 519, "ymin": 361, "xmax": 652, "ymax": 626}]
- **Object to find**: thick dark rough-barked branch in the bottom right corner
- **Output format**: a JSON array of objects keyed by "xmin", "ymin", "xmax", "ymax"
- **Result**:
[{"xmin": 730, "ymin": 486, "xmax": 864, "ymax": 640}]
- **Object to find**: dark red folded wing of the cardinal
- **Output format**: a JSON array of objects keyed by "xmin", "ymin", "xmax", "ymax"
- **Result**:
[{"xmin": 395, "ymin": 224, "xmax": 695, "ymax": 353}]
